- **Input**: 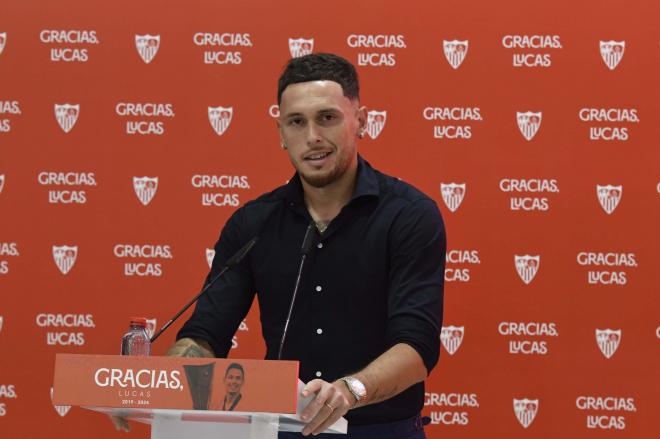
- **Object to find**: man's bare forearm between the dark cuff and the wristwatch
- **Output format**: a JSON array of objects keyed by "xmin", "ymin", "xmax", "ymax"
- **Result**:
[{"xmin": 353, "ymin": 343, "xmax": 428, "ymax": 406}]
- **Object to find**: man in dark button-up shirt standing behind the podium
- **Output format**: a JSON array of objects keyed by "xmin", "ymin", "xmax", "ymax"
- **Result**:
[{"xmin": 113, "ymin": 54, "xmax": 446, "ymax": 439}]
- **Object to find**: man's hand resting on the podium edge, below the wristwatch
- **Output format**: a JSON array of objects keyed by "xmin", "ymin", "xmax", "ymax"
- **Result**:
[{"xmin": 301, "ymin": 380, "xmax": 357, "ymax": 436}]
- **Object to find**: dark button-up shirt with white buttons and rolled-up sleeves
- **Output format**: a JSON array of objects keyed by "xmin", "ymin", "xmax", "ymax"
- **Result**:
[{"xmin": 177, "ymin": 157, "xmax": 446, "ymax": 425}]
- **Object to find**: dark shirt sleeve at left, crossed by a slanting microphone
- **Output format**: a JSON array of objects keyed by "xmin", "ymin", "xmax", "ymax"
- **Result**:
[{"xmin": 176, "ymin": 208, "xmax": 255, "ymax": 357}]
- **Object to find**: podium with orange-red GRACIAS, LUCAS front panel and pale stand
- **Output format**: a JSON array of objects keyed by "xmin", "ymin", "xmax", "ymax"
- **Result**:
[{"xmin": 53, "ymin": 354, "xmax": 348, "ymax": 439}]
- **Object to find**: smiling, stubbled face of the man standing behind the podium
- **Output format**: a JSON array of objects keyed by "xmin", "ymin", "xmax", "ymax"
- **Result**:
[{"xmin": 277, "ymin": 81, "xmax": 366, "ymax": 187}]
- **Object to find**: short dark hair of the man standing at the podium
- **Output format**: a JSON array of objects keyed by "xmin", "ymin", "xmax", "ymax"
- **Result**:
[{"xmin": 277, "ymin": 53, "xmax": 360, "ymax": 105}]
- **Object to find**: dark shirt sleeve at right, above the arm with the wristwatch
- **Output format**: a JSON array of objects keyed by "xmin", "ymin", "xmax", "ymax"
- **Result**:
[{"xmin": 386, "ymin": 199, "xmax": 446, "ymax": 373}]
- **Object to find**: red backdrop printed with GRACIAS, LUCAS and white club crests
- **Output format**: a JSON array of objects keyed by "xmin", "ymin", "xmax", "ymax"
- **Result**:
[{"xmin": 0, "ymin": 0, "xmax": 660, "ymax": 438}]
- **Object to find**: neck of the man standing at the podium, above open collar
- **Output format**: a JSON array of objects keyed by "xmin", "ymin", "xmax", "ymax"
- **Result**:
[{"xmin": 302, "ymin": 159, "xmax": 357, "ymax": 223}]
